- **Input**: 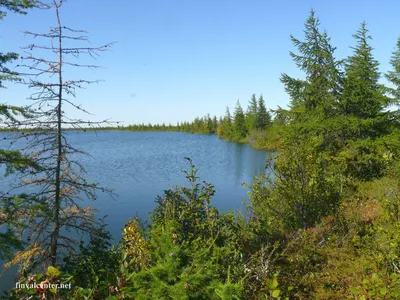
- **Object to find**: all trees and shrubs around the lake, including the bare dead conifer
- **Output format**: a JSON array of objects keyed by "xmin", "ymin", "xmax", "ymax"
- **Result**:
[{"xmin": 0, "ymin": 0, "xmax": 400, "ymax": 300}]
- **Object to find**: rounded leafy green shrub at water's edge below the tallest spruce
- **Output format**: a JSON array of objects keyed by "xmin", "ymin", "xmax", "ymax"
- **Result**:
[{"xmin": 249, "ymin": 141, "xmax": 345, "ymax": 232}]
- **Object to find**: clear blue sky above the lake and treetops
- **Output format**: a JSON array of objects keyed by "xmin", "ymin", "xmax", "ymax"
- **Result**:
[{"xmin": 0, "ymin": 0, "xmax": 400, "ymax": 125}]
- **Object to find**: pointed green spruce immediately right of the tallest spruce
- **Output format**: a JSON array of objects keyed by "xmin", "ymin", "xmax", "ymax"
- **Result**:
[{"xmin": 340, "ymin": 22, "xmax": 398, "ymax": 180}]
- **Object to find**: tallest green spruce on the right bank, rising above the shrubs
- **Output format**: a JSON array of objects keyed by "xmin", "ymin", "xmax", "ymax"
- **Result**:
[{"xmin": 281, "ymin": 10, "xmax": 344, "ymax": 153}]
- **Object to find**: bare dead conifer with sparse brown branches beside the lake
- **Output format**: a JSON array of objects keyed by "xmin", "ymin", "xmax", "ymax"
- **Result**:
[{"xmin": 3, "ymin": 0, "xmax": 113, "ymax": 270}]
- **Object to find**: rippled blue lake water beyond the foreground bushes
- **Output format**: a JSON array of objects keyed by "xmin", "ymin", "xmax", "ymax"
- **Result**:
[{"xmin": 0, "ymin": 131, "xmax": 268, "ymax": 287}]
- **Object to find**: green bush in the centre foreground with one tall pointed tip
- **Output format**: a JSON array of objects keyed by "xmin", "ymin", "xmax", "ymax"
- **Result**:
[{"xmin": 115, "ymin": 158, "xmax": 247, "ymax": 299}]
